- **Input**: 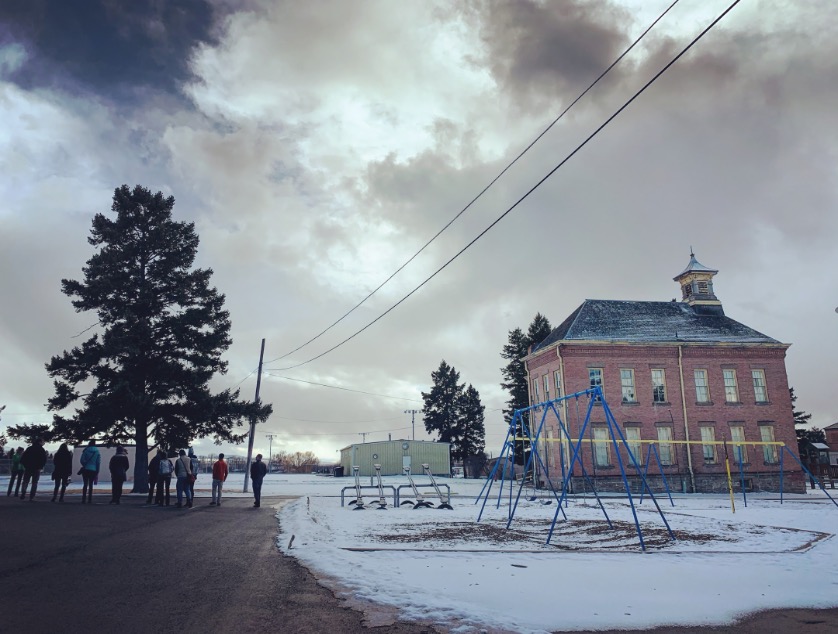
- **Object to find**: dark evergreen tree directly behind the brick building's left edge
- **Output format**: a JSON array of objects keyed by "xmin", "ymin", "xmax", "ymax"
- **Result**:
[{"xmin": 500, "ymin": 313, "xmax": 553, "ymax": 465}]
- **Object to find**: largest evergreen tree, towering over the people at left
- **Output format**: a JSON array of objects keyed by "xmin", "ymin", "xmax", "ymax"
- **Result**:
[{"xmin": 25, "ymin": 185, "xmax": 272, "ymax": 492}]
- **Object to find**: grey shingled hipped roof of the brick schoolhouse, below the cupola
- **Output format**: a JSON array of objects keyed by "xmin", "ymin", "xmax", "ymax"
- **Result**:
[{"xmin": 533, "ymin": 299, "xmax": 780, "ymax": 352}]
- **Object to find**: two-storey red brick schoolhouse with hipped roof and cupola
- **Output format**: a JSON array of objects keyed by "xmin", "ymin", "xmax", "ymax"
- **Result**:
[{"xmin": 524, "ymin": 253, "xmax": 805, "ymax": 492}]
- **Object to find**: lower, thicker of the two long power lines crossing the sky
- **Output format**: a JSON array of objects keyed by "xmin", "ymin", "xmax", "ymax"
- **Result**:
[{"xmin": 266, "ymin": 0, "xmax": 741, "ymax": 371}]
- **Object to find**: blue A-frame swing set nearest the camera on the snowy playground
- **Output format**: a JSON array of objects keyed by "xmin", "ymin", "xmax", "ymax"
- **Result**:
[{"xmin": 475, "ymin": 386, "xmax": 675, "ymax": 551}]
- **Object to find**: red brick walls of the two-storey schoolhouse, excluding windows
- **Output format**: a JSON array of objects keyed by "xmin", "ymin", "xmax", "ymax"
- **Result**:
[{"xmin": 527, "ymin": 344, "xmax": 800, "ymax": 488}]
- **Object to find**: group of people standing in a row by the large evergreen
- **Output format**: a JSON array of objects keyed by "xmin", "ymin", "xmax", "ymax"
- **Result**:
[{"xmin": 7, "ymin": 438, "xmax": 268, "ymax": 508}]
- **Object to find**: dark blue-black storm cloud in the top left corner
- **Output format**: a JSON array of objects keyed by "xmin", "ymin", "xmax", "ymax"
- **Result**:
[{"xmin": 0, "ymin": 0, "xmax": 233, "ymax": 100}]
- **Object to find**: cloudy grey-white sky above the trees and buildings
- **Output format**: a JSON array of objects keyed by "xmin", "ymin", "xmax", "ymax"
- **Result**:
[{"xmin": 0, "ymin": 0, "xmax": 838, "ymax": 460}]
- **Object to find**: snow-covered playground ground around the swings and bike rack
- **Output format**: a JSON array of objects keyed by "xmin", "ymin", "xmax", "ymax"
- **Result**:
[{"xmin": 265, "ymin": 475, "xmax": 838, "ymax": 632}]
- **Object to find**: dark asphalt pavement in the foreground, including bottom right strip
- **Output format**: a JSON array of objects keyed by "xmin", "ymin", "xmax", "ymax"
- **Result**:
[{"xmin": 0, "ymin": 491, "xmax": 838, "ymax": 634}]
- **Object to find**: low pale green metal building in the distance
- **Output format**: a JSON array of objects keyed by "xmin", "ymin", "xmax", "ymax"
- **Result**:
[{"xmin": 340, "ymin": 440, "xmax": 451, "ymax": 476}]
